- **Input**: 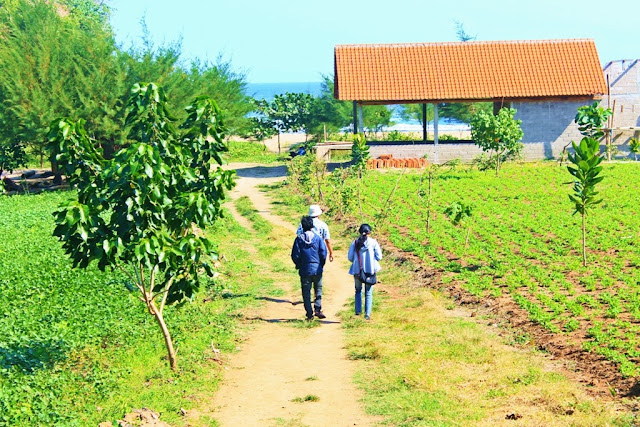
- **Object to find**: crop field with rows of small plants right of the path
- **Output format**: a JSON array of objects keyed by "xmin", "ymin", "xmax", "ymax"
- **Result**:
[{"xmin": 282, "ymin": 162, "xmax": 640, "ymax": 394}]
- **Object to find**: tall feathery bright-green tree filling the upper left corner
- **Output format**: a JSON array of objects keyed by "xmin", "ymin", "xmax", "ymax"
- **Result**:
[{"xmin": 0, "ymin": 0, "xmax": 125, "ymax": 166}]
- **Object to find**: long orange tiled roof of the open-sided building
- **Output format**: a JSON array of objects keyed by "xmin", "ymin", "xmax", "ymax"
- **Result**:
[{"xmin": 334, "ymin": 39, "xmax": 606, "ymax": 102}]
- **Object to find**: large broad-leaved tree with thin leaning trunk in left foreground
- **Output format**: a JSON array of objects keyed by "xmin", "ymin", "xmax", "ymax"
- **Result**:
[{"xmin": 50, "ymin": 83, "xmax": 233, "ymax": 370}]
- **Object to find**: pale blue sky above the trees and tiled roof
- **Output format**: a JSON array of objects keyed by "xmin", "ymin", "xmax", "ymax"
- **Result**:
[{"xmin": 108, "ymin": 0, "xmax": 640, "ymax": 83}]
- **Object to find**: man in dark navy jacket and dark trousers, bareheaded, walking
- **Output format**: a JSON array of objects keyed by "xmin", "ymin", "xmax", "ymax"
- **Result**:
[{"xmin": 291, "ymin": 216, "xmax": 327, "ymax": 320}]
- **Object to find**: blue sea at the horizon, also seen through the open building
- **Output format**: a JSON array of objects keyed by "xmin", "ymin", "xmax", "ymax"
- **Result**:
[{"xmin": 247, "ymin": 82, "xmax": 469, "ymax": 132}]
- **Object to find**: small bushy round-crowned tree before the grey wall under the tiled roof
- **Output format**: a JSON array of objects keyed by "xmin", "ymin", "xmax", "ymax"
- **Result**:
[{"xmin": 471, "ymin": 108, "xmax": 524, "ymax": 176}]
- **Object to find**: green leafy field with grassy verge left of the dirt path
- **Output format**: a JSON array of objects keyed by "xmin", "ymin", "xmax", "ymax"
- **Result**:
[{"xmin": 0, "ymin": 192, "xmax": 284, "ymax": 426}]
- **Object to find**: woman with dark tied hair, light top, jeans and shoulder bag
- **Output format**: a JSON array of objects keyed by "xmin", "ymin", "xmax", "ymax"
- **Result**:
[{"xmin": 348, "ymin": 224, "xmax": 382, "ymax": 320}]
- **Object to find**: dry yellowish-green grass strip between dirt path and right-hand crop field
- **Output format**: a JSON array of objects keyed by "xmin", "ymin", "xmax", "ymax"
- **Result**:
[{"xmin": 342, "ymin": 259, "xmax": 632, "ymax": 425}]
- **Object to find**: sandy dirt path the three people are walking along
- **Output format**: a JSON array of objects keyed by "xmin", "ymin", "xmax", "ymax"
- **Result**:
[{"xmin": 202, "ymin": 165, "xmax": 377, "ymax": 426}]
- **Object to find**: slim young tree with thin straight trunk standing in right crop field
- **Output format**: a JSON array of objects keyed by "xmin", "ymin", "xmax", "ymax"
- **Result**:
[{"xmin": 567, "ymin": 137, "xmax": 603, "ymax": 266}]
